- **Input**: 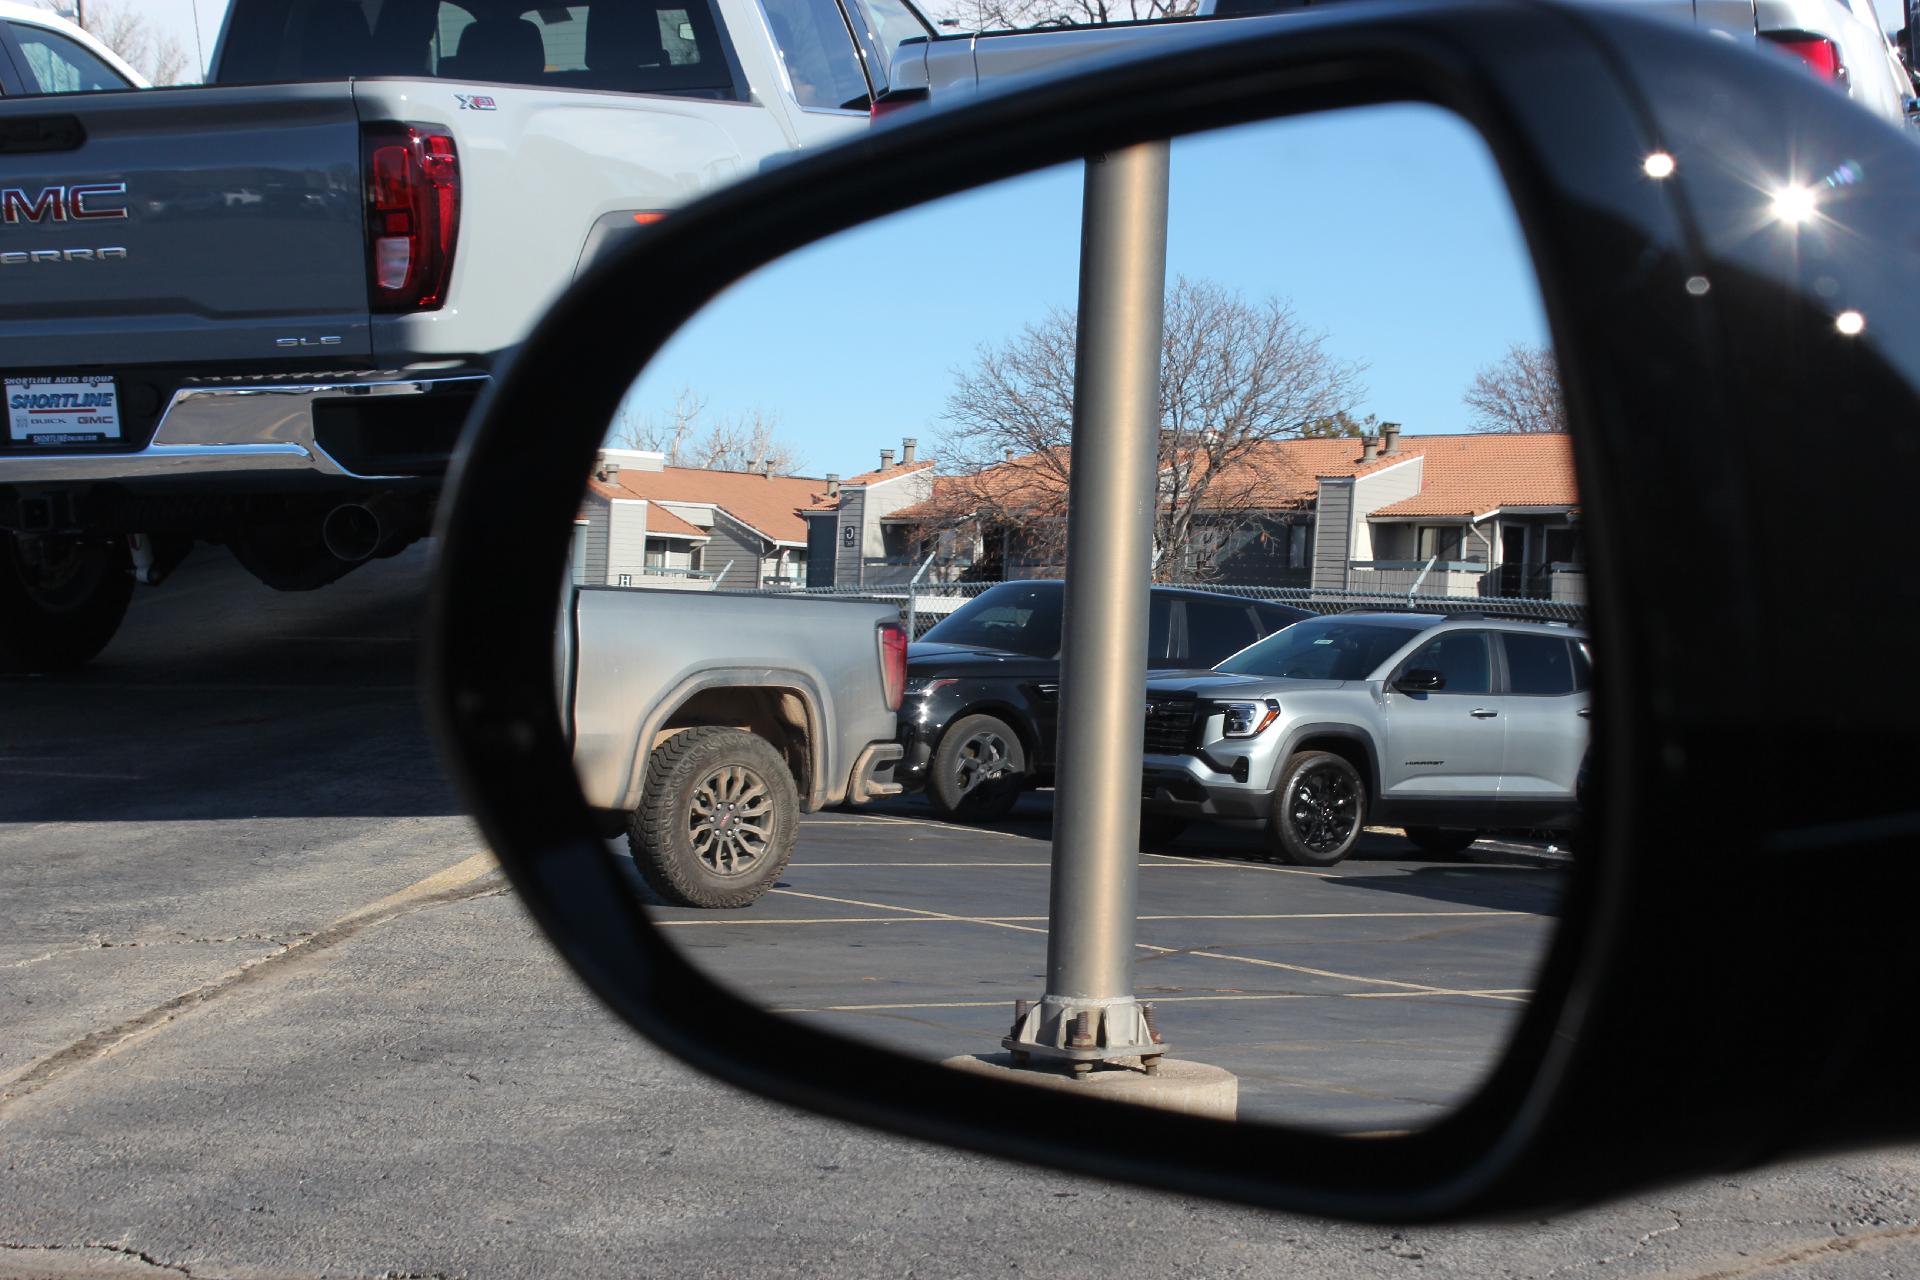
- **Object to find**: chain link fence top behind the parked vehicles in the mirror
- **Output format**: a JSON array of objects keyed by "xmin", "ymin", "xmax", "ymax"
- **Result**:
[{"xmin": 725, "ymin": 581, "xmax": 1586, "ymax": 639}]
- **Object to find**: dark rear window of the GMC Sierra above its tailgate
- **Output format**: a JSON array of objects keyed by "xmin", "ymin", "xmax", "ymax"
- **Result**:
[{"xmin": 215, "ymin": 0, "xmax": 741, "ymax": 98}]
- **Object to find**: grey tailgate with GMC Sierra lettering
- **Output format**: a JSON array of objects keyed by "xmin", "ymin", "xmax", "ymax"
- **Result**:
[{"xmin": 0, "ymin": 83, "xmax": 369, "ymax": 372}]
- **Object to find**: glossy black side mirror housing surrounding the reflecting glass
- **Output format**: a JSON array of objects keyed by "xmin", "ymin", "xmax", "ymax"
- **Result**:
[{"xmin": 428, "ymin": 0, "xmax": 1920, "ymax": 1221}]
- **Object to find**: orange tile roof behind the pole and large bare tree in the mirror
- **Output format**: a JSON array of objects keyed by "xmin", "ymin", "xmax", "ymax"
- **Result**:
[{"xmin": 887, "ymin": 434, "xmax": 1578, "ymax": 520}]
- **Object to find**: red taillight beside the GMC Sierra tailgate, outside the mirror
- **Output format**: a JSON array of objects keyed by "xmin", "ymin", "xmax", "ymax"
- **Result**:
[{"xmin": 363, "ymin": 125, "xmax": 461, "ymax": 311}]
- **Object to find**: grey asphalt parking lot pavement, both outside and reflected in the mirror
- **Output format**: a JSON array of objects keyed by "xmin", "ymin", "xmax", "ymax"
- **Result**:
[{"xmin": 0, "ymin": 547, "xmax": 1920, "ymax": 1280}]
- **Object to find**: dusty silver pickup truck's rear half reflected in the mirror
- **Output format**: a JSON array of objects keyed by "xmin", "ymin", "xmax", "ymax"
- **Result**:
[{"xmin": 555, "ymin": 587, "xmax": 906, "ymax": 908}]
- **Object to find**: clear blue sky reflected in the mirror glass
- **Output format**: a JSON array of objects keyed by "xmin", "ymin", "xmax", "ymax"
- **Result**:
[{"xmin": 630, "ymin": 106, "xmax": 1546, "ymax": 474}]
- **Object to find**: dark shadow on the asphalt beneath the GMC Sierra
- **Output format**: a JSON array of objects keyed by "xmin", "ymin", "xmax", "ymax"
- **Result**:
[{"xmin": 0, "ymin": 543, "xmax": 463, "ymax": 821}]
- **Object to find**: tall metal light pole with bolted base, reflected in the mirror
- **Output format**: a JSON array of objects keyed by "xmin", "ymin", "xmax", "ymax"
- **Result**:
[{"xmin": 1002, "ymin": 142, "xmax": 1169, "ymax": 1075}]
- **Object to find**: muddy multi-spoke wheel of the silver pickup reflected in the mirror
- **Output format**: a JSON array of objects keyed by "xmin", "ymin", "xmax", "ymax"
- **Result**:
[{"xmin": 626, "ymin": 725, "xmax": 801, "ymax": 908}]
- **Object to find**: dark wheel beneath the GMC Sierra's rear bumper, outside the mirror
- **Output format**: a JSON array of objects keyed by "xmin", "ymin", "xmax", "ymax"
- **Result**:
[{"xmin": 0, "ymin": 533, "xmax": 132, "ymax": 672}]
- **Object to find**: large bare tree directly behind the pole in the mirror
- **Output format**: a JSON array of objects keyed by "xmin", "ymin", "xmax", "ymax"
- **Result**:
[{"xmin": 941, "ymin": 276, "xmax": 1361, "ymax": 580}]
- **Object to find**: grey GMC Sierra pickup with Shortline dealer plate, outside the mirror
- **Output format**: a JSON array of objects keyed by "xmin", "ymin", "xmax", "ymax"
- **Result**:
[{"xmin": 0, "ymin": 0, "xmax": 929, "ymax": 672}]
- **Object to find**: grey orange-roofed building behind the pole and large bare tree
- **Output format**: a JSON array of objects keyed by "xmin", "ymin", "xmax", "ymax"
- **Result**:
[{"xmin": 806, "ymin": 426, "xmax": 1584, "ymax": 599}]
